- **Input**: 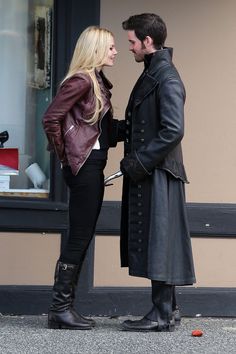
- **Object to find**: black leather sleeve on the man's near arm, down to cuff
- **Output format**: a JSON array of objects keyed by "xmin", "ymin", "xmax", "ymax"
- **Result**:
[{"xmin": 121, "ymin": 78, "xmax": 185, "ymax": 182}]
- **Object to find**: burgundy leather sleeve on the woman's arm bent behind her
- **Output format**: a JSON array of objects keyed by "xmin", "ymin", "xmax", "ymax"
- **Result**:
[{"xmin": 42, "ymin": 75, "xmax": 91, "ymax": 162}]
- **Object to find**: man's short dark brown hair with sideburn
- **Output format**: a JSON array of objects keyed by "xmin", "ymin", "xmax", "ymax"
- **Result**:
[{"xmin": 122, "ymin": 13, "xmax": 167, "ymax": 49}]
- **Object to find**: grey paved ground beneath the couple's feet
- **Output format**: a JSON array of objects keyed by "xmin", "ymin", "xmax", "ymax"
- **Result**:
[{"xmin": 0, "ymin": 316, "xmax": 236, "ymax": 354}]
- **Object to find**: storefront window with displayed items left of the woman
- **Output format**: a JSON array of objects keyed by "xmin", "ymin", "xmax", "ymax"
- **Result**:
[{"xmin": 0, "ymin": 0, "xmax": 53, "ymax": 198}]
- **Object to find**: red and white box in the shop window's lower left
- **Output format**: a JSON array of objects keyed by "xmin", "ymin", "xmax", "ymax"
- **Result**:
[{"xmin": 0, "ymin": 148, "xmax": 19, "ymax": 175}]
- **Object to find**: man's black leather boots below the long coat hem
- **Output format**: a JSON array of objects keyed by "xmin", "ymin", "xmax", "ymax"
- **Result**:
[{"xmin": 122, "ymin": 280, "xmax": 175, "ymax": 332}]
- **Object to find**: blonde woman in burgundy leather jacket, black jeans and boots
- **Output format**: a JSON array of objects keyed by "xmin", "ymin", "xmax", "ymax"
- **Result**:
[{"xmin": 43, "ymin": 26, "xmax": 124, "ymax": 329}]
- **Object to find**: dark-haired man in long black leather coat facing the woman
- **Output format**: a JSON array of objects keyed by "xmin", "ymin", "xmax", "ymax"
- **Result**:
[{"xmin": 120, "ymin": 13, "xmax": 195, "ymax": 331}]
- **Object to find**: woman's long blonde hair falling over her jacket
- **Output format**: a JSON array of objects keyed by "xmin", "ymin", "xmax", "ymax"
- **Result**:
[{"xmin": 62, "ymin": 26, "xmax": 113, "ymax": 124}]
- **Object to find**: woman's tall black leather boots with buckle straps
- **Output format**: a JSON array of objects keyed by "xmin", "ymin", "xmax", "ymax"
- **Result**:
[{"xmin": 48, "ymin": 261, "xmax": 92, "ymax": 329}]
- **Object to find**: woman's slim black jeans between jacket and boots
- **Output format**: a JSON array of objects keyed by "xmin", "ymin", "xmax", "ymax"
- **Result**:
[{"xmin": 60, "ymin": 160, "xmax": 106, "ymax": 266}]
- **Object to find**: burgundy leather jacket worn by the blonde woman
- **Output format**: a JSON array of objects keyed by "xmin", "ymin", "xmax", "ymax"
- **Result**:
[{"xmin": 43, "ymin": 72, "xmax": 123, "ymax": 175}]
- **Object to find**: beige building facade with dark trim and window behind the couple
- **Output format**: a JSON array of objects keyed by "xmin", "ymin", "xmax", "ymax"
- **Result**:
[{"xmin": 0, "ymin": 0, "xmax": 236, "ymax": 316}]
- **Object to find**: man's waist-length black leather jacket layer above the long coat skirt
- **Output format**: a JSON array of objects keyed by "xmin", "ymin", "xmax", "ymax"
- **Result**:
[{"xmin": 121, "ymin": 48, "xmax": 187, "ymax": 182}]
